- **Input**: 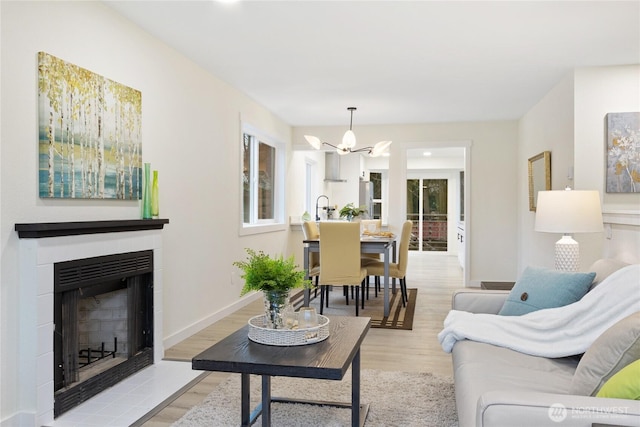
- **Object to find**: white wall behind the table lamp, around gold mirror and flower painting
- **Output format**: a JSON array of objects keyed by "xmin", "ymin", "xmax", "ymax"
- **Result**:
[{"xmin": 518, "ymin": 65, "xmax": 640, "ymax": 272}]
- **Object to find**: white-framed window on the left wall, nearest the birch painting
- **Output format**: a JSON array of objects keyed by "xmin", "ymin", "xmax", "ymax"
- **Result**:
[{"xmin": 242, "ymin": 125, "xmax": 284, "ymax": 227}]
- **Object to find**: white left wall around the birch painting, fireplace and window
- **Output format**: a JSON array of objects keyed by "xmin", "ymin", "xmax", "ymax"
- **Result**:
[{"xmin": 0, "ymin": 1, "xmax": 291, "ymax": 421}]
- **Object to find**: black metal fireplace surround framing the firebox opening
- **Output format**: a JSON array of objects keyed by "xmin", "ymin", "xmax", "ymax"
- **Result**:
[{"xmin": 53, "ymin": 250, "xmax": 153, "ymax": 417}]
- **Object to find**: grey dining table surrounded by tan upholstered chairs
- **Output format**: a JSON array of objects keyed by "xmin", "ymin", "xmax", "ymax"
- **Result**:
[{"xmin": 302, "ymin": 234, "xmax": 396, "ymax": 317}]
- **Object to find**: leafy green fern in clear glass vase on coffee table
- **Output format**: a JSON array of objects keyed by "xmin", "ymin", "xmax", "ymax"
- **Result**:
[{"xmin": 233, "ymin": 248, "xmax": 311, "ymax": 329}]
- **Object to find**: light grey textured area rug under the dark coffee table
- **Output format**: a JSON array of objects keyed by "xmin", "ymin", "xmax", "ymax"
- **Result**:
[{"xmin": 173, "ymin": 369, "xmax": 458, "ymax": 427}]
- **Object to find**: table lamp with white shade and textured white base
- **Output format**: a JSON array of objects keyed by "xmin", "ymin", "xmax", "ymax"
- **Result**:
[{"xmin": 534, "ymin": 188, "xmax": 603, "ymax": 271}]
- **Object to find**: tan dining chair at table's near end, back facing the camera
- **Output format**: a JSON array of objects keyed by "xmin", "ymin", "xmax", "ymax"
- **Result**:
[{"xmin": 320, "ymin": 221, "xmax": 367, "ymax": 316}]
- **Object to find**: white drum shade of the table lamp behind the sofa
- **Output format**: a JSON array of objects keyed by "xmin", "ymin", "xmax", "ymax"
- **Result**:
[{"xmin": 534, "ymin": 190, "xmax": 603, "ymax": 234}]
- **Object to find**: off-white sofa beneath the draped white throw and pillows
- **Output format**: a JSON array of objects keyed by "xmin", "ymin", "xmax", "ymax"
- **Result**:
[{"xmin": 452, "ymin": 263, "xmax": 640, "ymax": 427}]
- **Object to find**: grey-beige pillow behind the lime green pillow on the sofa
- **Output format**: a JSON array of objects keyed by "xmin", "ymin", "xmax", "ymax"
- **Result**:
[{"xmin": 570, "ymin": 312, "xmax": 640, "ymax": 396}]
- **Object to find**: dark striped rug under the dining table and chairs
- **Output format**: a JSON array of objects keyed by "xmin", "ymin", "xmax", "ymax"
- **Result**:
[{"xmin": 291, "ymin": 286, "xmax": 418, "ymax": 330}]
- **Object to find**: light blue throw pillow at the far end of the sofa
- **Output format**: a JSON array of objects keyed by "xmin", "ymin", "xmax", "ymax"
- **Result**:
[{"xmin": 498, "ymin": 267, "xmax": 596, "ymax": 316}]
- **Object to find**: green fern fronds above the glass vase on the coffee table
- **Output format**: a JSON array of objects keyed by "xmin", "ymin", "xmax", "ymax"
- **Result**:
[{"xmin": 233, "ymin": 248, "xmax": 311, "ymax": 295}]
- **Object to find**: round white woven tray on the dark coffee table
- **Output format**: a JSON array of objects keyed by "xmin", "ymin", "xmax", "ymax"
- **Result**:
[{"xmin": 249, "ymin": 314, "xmax": 329, "ymax": 347}]
